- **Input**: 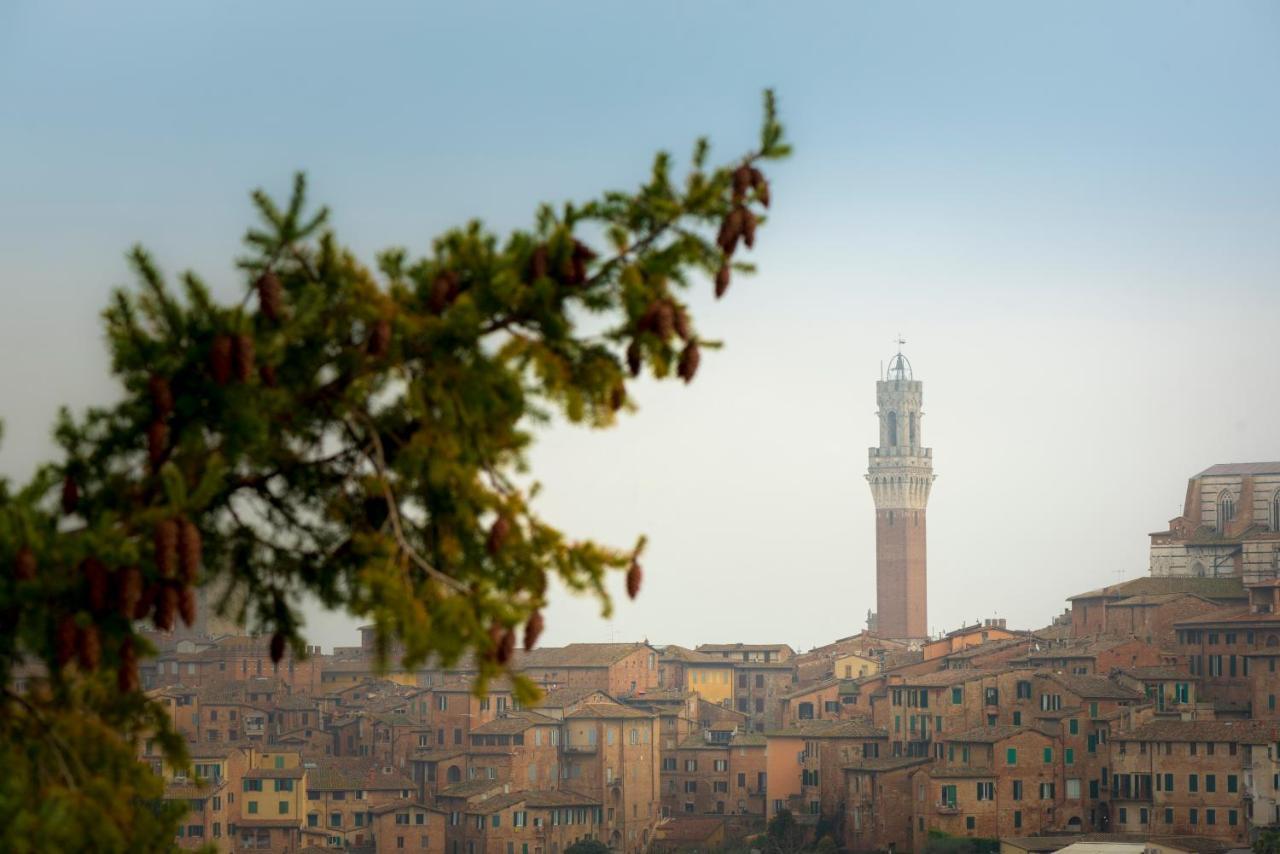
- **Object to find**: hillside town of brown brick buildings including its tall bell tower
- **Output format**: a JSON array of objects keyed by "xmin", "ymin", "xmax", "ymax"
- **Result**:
[{"xmin": 35, "ymin": 352, "xmax": 1280, "ymax": 854}]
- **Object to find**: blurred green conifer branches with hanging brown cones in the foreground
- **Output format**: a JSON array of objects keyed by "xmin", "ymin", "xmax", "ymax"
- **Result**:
[{"xmin": 0, "ymin": 93, "xmax": 788, "ymax": 851}]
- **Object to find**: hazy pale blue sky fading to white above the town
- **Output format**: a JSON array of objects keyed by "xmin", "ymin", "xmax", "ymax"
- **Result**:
[{"xmin": 0, "ymin": 0, "xmax": 1280, "ymax": 648}]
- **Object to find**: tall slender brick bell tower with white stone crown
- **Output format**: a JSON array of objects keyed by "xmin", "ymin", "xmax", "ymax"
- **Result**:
[{"xmin": 867, "ymin": 339, "xmax": 934, "ymax": 640}]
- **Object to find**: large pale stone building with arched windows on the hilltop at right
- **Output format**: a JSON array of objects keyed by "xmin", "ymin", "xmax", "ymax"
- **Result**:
[{"xmin": 1151, "ymin": 462, "xmax": 1280, "ymax": 581}]
